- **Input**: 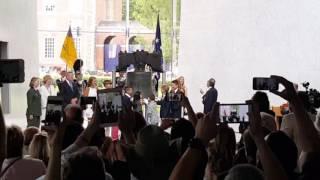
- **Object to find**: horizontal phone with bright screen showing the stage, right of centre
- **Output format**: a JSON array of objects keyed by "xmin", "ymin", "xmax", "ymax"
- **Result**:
[{"xmin": 219, "ymin": 103, "xmax": 251, "ymax": 123}]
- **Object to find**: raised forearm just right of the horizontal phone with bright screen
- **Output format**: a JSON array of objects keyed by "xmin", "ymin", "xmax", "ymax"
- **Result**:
[{"xmin": 249, "ymin": 102, "xmax": 288, "ymax": 180}]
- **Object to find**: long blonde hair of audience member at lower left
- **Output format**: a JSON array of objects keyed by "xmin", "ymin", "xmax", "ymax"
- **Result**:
[{"xmin": 29, "ymin": 133, "xmax": 50, "ymax": 165}]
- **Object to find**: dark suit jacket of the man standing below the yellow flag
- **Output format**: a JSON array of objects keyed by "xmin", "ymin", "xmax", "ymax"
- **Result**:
[{"xmin": 61, "ymin": 81, "xmax": 80, "ymax": 105}]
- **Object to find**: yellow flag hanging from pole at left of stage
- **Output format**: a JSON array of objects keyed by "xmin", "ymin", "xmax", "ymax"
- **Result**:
[{"xmin": 60, "ymin": 27, "xmax": 77, "ymax": 68}]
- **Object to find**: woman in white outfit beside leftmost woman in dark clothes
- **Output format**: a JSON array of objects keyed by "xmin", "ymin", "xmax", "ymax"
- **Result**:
[{"xmin": 39, "ymin": 75, "xmax": 57, "ymax": 120}]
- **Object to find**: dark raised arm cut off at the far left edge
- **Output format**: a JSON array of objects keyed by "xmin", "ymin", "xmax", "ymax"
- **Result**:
[{"xmin": 0, "ymin": 102, "xmax": 7, "ymax": 167}]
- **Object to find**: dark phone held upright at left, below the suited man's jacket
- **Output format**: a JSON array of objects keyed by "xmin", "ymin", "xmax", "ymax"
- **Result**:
[{"xmin": 43, "ymin": 96, "xmax": 63, "ymax": 126}]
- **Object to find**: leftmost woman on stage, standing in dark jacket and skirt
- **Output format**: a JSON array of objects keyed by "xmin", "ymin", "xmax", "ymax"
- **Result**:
[{"xmin": 26, "ymin": 77, "xmax": 42, "ymax": 128}]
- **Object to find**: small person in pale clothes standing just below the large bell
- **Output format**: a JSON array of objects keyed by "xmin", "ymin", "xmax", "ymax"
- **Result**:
[{"xmin": 147, "ymin": 95, "xmax": 160, "ymax": 125}]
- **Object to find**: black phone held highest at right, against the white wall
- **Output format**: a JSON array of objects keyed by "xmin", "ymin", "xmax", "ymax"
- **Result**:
[{"xmin": 253, "ymin": 77, "xmax": 279, "ymax": 91}]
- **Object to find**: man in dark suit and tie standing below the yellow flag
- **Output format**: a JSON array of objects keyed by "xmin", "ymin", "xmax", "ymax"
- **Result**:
[{"xmin": 61, "ymin": 72, "xmax": 80, "ymax": 105}]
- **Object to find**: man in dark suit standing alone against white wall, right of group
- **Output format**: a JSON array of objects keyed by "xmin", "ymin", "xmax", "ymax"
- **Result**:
[{"xmin": 200, "ymin": 78, "xmax": 218, "ymax": 114}]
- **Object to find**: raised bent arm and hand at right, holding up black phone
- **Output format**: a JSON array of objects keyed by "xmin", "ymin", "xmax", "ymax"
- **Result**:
[{"xmin": 271, "ymin": 76, "xmax": 320, "ymax": 152}]
